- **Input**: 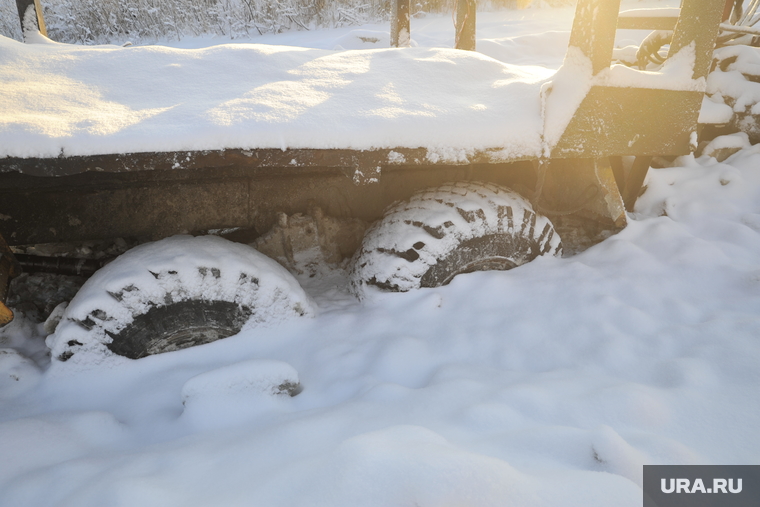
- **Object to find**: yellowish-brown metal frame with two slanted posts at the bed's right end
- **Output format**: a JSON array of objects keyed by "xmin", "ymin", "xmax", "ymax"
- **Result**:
[{"xmin": 547, "ymin": 0, "xmax": 725, "ymax": 216}]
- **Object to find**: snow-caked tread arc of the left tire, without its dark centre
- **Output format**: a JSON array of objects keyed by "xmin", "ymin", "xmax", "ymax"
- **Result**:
[{"xmin": 47, "ymin": 236, "xmax": 314, "ymax": 365}]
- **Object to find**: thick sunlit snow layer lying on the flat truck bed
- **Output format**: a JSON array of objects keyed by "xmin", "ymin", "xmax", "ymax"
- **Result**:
[{"xmin": 0, "ymin": 37, "xmax": 553, "ymax": 157}]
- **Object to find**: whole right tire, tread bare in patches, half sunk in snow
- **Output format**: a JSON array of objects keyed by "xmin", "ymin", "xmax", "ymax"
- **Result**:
[{"xmin": 350, "ymin": 182, "xmax": 562, "ymax": 298}]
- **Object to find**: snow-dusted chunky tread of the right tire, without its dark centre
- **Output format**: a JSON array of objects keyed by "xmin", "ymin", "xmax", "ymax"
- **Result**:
[{"xmin": 350, "ymin": 182, "xmax": 561, "ymax": 298}]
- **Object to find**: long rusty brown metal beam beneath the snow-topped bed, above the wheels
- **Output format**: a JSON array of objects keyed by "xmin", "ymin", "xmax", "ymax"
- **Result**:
[{"xmin": 0, "ymin": 161, "xmax": 534, "ymax": 245}]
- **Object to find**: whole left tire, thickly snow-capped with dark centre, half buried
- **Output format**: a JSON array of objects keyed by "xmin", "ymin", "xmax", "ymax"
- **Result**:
[{"xmin": 47, "ymin": 236, "xmax": 314, "ymax": 361}]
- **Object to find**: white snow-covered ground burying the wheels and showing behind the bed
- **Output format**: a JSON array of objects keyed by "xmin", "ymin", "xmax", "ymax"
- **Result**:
[{"xmin": 0, "ymin": 1, "xmax": 760, "ymax": 507}]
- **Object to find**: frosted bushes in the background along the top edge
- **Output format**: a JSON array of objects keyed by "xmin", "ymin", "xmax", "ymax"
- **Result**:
[{"xmin": 0, "ymin": 0, "xmax": 572, "ymax": 44}]
